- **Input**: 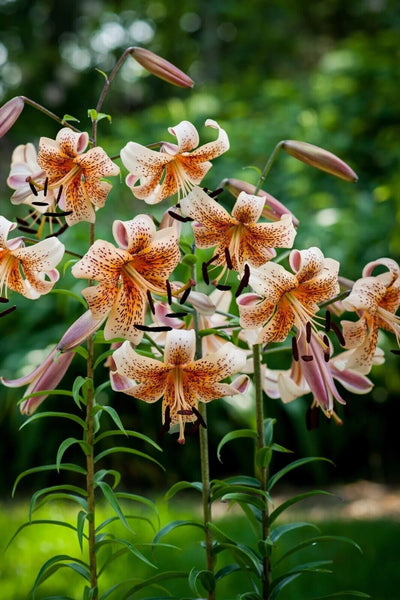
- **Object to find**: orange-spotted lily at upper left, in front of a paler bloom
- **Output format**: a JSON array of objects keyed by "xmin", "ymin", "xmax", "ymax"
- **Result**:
[{"xmin": 37, "ymin": 127, "xmax": 119, "ymax": 225}]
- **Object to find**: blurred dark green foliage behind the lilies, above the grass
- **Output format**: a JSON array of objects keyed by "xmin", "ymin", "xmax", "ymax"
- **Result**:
[{"xmin": 0, "ymin": 0, "xmax": 400, "ymax": 497}]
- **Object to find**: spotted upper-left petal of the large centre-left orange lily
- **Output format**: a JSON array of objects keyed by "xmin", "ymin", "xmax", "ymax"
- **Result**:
[{"xmin": 71, "ymin": 240, "xmax": 132, "ymax": 285}]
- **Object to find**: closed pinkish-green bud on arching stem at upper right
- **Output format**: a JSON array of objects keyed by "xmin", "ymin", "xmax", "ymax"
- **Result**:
[{"xmin": 282, "ymin": 140, "xmax": 358, "ymax": 183}]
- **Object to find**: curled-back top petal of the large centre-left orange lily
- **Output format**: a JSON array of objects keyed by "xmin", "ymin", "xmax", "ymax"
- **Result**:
[{"xmin": 112, "ymin": 215, "xmax": 156, "ymax": 254}]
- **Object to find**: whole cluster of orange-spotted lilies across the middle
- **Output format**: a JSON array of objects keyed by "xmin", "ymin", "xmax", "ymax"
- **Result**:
[{"xmin": 0, "ymin": 68, "xmax": 400, "ymax": 443}]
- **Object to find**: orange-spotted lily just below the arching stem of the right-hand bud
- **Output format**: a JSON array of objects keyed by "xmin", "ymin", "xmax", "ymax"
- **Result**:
[{"xmin": 180, "ymin": 187, "xmax": 296, "ymax": 278}]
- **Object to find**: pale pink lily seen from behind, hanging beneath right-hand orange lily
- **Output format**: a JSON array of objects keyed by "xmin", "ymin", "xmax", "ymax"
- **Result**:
[{"xmin": 262, "ymin": 332, "xmax": 373, "ymax": 424}]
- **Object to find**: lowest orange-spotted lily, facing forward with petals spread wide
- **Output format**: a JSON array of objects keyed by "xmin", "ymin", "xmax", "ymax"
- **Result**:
[{"xmin": 112, "ymin": 329, "xmax": 246, "ymax": 444}]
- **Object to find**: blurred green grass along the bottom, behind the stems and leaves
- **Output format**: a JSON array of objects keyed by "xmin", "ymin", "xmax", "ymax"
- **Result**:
[{"xmin": 0, "ymin": 496, "xmax": 400, "ymax": 600}]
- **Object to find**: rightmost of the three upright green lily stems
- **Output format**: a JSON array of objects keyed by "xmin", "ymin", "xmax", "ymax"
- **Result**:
[{"xmin": 253, "ymin": 344, "xmax": 271, "ymax": 600}]
